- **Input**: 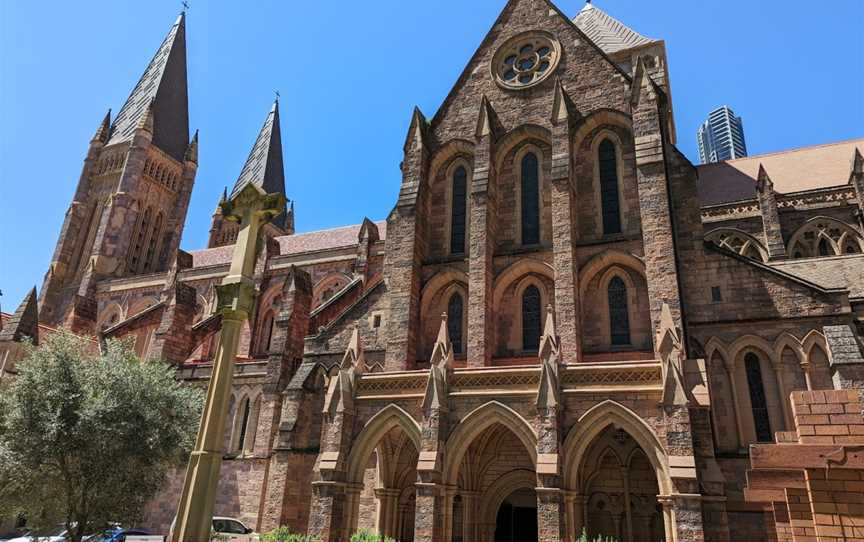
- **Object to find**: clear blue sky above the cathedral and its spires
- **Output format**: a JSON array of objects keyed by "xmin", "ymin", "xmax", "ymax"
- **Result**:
[{"xmin": 0, "ymin": 0, "xmax": 864, "ymax": 312}]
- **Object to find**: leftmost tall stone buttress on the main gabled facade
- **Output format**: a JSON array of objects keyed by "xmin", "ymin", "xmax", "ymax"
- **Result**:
[{"xmin": 384, "ymin": 108, "xmax": 429, "ymax": 371}]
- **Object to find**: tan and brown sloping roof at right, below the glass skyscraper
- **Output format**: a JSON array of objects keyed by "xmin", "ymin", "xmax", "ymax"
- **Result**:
[{"xmin": 696, "ymin": 139, "xmax": 864, "ymax": 205}]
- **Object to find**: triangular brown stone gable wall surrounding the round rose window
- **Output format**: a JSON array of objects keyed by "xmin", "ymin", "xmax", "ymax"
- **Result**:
[{"xmin": 431, "ymin": 0, "xmax": 629, "ymax": 143}]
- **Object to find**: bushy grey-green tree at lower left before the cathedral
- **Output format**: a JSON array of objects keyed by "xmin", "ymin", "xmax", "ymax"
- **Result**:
[{"xmin": 0, "ymin": 332, "xmax": 203, "ymax": 542}]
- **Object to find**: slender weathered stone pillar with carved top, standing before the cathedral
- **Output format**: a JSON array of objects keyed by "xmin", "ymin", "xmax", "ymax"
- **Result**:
[{"xmin": 171, "ymin": 184, "xmax": 285, "ymax": 542}]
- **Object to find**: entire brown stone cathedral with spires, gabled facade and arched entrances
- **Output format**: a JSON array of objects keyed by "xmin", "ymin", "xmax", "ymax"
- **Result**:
[{"xmin": 0, "ymin": 0, "xmax": 864, "ymax": 542}]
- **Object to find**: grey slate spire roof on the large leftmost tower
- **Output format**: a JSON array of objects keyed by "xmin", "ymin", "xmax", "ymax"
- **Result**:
[{"xmin": 107, "ymin": 12, "xmax": 189, "ymax": 162}]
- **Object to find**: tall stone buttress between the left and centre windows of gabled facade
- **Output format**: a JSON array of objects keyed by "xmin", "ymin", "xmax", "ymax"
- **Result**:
[{"xmin": 467, "ymin": 96, "xmax": 496, "ymax": 367}]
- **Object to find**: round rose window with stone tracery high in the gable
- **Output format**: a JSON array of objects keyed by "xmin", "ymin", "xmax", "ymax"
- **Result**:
[{"xmin": 492, "ymin": 32, "xmax": 561, "ymax": 89}]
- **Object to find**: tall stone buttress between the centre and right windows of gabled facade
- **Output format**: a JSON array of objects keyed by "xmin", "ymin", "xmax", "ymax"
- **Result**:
[{"xmin": 550, "ymin": 81, "xmax": 582, "ymax": 363}]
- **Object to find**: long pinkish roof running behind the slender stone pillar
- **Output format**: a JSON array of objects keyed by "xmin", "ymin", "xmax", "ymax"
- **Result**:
[{"xmin": 190, "ymin": 220, "xmax": 387, "ymax": 267}]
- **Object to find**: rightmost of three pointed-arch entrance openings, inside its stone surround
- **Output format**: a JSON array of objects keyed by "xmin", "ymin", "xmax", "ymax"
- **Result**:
[{"xmin": 580, "ymin": 425, "xmax": 666, "ymax": 542}]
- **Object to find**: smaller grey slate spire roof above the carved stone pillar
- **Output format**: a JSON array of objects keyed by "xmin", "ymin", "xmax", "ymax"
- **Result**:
[{"xmin": 231, "ymin": 99, "xmax": 286, "ymax": 227}]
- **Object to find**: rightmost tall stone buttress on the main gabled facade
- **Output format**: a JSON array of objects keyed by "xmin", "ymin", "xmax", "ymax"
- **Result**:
[{"xmin": 632, "ymin": 57, "xmax": 682, "ymax": 342}]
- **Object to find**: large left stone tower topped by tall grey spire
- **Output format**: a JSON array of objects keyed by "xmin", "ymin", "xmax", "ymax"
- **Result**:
[{"xmin": 39, "ymin": 13, "xmax": 198, "ymax": 332}]
